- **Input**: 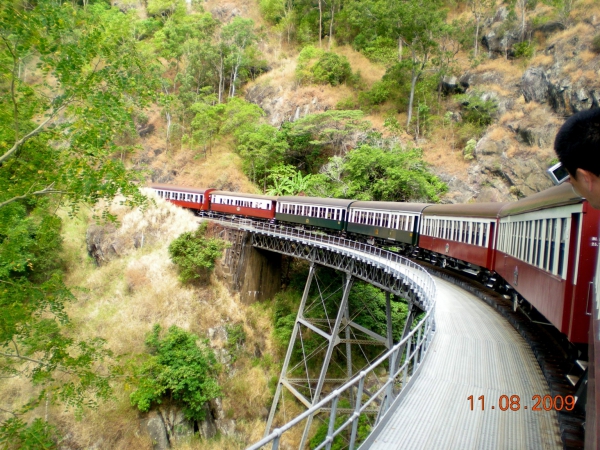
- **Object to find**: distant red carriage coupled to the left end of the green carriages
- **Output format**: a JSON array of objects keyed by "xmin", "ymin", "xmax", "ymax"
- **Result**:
[{"xmin": 210, "ymin": 191, "xmax": 277, "ymax": 219}]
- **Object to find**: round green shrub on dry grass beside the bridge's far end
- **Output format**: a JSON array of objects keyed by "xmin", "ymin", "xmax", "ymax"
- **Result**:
[{"xmin": 169, "ymin": 222, "xmax": 227, "ymax": 283}]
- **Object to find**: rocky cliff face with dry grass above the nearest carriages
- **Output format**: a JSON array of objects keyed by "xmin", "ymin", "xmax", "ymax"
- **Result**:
[{"xmin": 440, "ymin": 9, "xmax": 600, "ymax": 202}]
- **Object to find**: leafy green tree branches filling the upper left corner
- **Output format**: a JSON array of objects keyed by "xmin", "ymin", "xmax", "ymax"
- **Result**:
[{"xmin": 0, "ymin": 0, "xmax": 148, "ymax": 214}]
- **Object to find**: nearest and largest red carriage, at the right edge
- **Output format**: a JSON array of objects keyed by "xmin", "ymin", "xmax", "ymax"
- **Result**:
[{"xmin": 495, "ymin": 184, "xmax": 600, "ymax": 343}]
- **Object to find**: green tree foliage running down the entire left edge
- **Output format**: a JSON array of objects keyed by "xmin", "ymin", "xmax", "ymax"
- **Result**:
[{"xmin": 0, "ymin": 0, "xmax": 158, "ymax": 440}]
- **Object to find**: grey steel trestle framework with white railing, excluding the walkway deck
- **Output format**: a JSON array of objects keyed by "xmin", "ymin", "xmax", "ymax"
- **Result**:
[{"xmin": 207, "ymin": 219, "xmax": 436, "ymax": 450}]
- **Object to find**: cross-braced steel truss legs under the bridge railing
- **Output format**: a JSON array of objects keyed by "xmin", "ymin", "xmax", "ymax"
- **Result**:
[{"xmin": 266, "ymin": 262, "xmax": 418, "ymax": 448}]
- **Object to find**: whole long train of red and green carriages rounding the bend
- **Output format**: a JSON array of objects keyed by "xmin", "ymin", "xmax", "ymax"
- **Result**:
[{"xmin": 150, "ymin": 183, "xmax": 600, "ymax": 345}]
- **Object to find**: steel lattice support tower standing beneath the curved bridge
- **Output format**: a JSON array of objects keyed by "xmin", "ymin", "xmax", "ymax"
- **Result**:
[{"xmin": 265, "ymin": 262, "xmax": 410, "ymax": 448}]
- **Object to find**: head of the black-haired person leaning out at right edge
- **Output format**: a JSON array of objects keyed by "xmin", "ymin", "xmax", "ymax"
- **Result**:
[{"xmin": 554, "ymin": 108, "xmax": 600, "ymax": 209}]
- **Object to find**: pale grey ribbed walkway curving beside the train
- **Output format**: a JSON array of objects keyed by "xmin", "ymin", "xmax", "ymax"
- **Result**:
[{"xmin": 361, "ymin": 278, "xmax": 562, "ymax": 450}]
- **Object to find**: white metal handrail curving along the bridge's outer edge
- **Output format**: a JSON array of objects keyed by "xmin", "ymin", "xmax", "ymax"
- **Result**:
[{"xmin": 206, "ymin": 219, "xmax": 436, "ymax": 450}]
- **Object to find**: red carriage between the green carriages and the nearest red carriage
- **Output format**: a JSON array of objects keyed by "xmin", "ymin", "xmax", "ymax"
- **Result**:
[{"xmin": 419, "ymin": 203, "xmax": 505, "ymax": 275}]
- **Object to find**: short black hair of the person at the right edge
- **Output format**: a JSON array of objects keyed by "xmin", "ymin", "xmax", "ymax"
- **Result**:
[{"xmin": 554, "ymin": 108, "xmax": 600, "ymax": 177}]
